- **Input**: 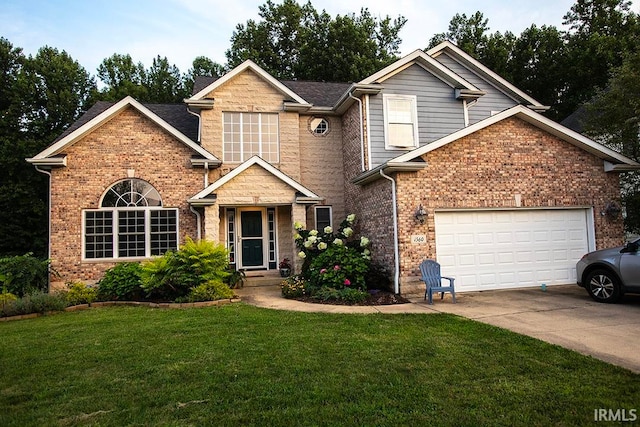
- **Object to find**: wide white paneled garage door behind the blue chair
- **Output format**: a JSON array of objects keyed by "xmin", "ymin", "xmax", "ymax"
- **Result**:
[{"xmin": 435, "ymin": 209, "xmax": 592, "ymax": 292}]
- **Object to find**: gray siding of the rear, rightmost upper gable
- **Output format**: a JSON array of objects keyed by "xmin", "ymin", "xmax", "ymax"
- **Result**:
[{"xmin": 435, "ymin": 53, "xmax": 518, "ymax": 125}]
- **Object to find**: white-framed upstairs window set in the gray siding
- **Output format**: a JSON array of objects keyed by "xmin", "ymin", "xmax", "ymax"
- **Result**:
[{"xmin": 382, "ymin": 94, "xmax": 418, "ymax": 149}]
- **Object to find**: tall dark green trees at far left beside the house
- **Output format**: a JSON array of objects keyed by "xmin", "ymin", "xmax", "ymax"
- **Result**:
[{"xmin": 0, "ymin": 42, "xmax": 96, "ymax": 256}]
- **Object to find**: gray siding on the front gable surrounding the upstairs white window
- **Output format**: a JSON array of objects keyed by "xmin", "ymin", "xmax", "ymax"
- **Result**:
[{"xmin": 369, "ymin": 65, "xmax": 464, "ymax": 168}]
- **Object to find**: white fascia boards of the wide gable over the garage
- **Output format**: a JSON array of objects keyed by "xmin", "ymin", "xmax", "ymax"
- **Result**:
[{"xmin": 389, "ymin": 105, "xmax": 640, "ymax": 166}]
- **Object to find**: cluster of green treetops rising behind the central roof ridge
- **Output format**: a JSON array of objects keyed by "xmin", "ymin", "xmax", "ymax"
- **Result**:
[{"xmin": 226, "ymin": 0, "xmax": 406, "ymax": 81}]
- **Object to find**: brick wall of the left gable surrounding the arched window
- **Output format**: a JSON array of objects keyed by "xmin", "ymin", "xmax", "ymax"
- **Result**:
[{"xmin": 51, "ymin": 108, "xmax": 203, "ymax": 286}]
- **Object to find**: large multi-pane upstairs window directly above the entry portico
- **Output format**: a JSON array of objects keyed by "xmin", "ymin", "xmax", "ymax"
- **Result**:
[{"xmin": 222, "ymin": 113, "xmax": 279, "ymax": 163}]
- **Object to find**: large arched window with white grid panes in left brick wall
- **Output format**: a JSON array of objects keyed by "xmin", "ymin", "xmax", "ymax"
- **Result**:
[{"xmin": 83, "ymin": 178, "xmax": 178, "ymax": 259}]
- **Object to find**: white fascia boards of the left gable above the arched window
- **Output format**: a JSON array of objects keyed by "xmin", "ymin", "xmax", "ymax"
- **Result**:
[{"xmin": 33, "ymin": 96, "xmax": 221, "ymax": 163}]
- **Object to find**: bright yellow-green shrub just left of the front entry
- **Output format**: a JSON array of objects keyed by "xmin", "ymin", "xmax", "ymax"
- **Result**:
[{"xmin": 141, "ymin": 238, "xmax": 230, "ymax": 300}]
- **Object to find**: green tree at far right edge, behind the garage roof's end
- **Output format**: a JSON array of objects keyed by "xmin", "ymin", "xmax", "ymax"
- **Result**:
[{"xmin": 584, "ymin": 52, "xmax": 640, "ymax": 233}]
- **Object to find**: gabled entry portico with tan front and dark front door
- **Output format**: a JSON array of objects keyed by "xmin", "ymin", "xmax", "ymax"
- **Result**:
[{"xmin": 189, "ymin": 156, "xmax": 323, "ymax": 270}]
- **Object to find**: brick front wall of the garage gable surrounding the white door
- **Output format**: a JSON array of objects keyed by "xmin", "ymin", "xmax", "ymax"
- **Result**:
[{"xmin": 398, "ymin": 118, "xmax": 623, "ymax": 278}]
